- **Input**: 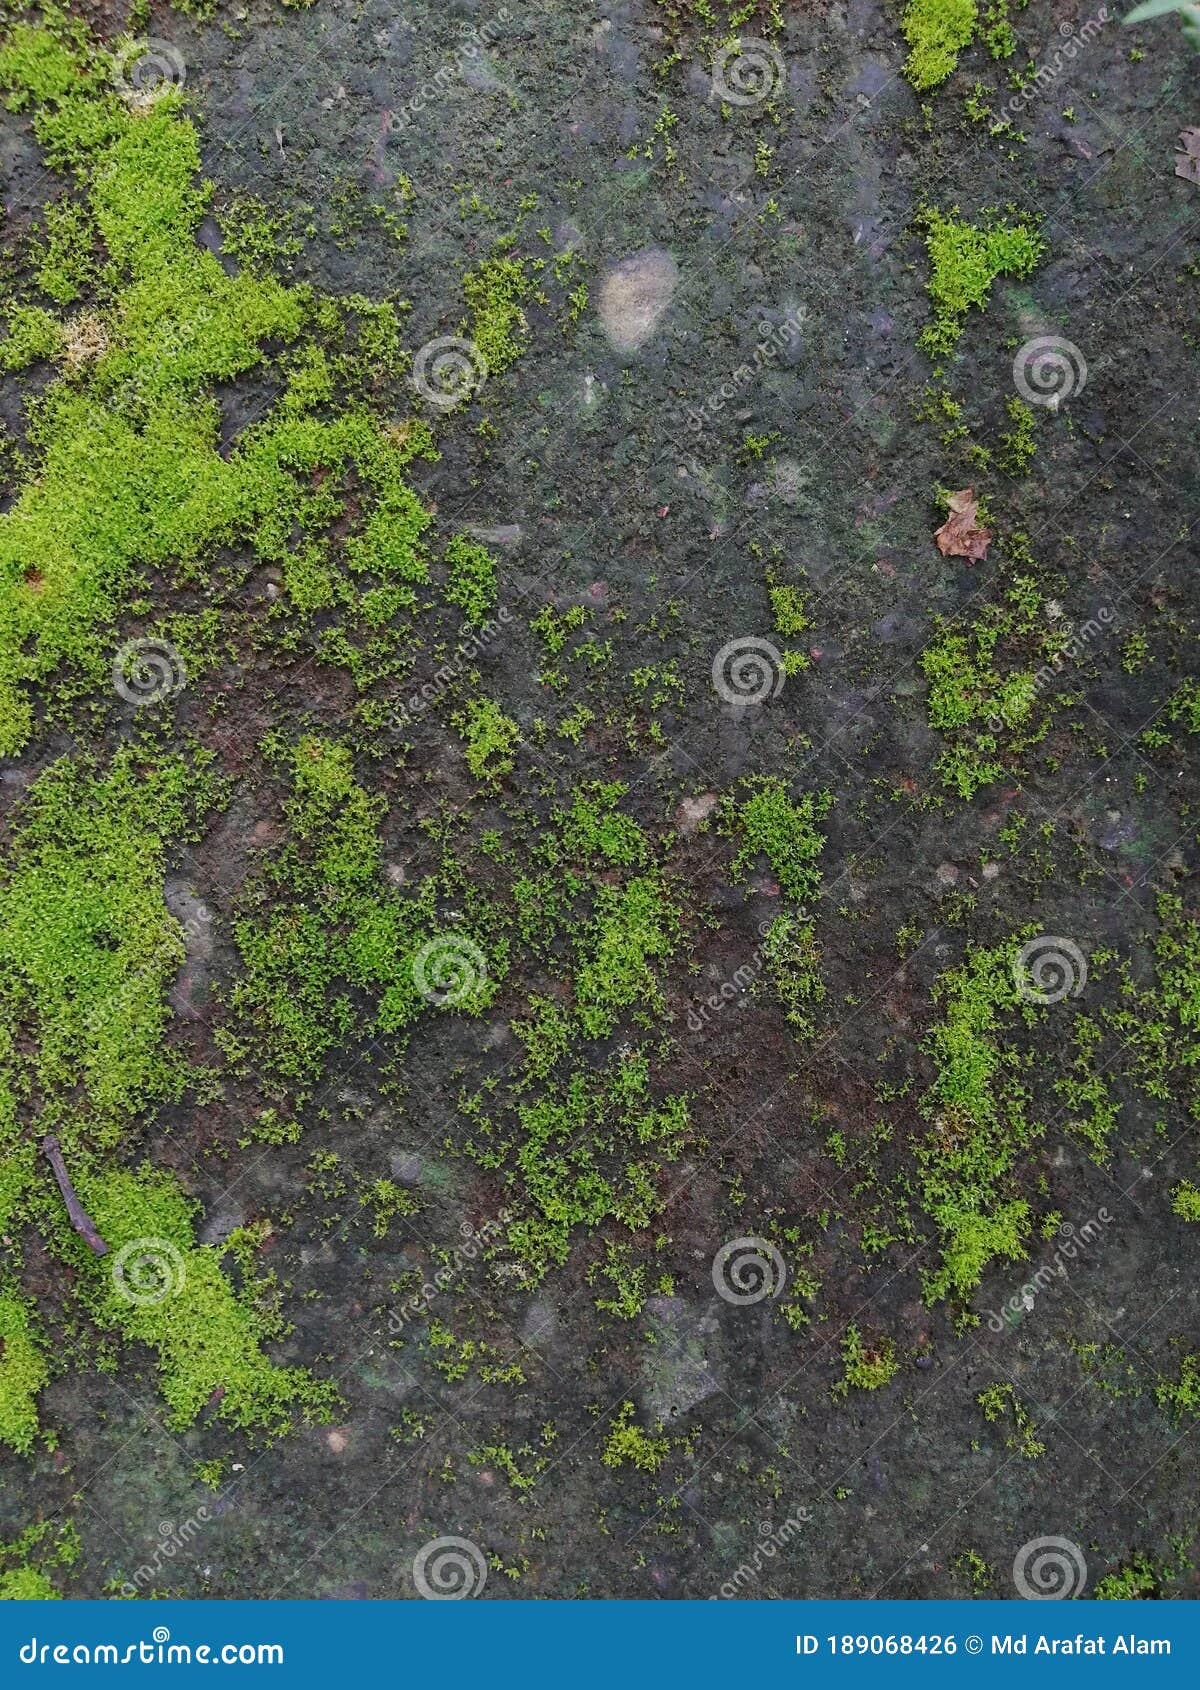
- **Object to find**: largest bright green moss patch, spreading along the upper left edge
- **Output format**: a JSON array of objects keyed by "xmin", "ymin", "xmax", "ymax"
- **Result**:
[{"xmin": 0, "ymin": 30, "xmax": 433, "ymax": 754}]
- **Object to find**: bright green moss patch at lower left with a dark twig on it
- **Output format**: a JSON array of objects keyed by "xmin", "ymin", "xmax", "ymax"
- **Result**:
[{"xmin": 0, "ymin": 747, "xmax": 338, "ymax": 1452}]
